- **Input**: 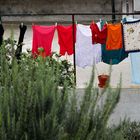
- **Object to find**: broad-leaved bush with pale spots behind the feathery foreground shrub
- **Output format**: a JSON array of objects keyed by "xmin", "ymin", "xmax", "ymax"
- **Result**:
[{"xmin": 3, "ymin": 35, "xmax": 75, "ymax": 87}]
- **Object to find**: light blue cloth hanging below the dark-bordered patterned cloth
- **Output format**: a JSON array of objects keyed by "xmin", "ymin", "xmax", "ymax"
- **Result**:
[{"xmin": 130, "ymin": 52, "xmax": 140, "ymax": 84}]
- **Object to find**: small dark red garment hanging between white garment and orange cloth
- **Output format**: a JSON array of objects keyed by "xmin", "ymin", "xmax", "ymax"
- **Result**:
[{"xmin": 90, "ymin": 22, "xmax": 107, "ymax": 44}]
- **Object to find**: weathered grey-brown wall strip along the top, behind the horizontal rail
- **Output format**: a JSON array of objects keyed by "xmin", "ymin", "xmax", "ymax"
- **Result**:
[{"xmin": 0, "ymin": 0, "xmax": 122, "ymax": 21}]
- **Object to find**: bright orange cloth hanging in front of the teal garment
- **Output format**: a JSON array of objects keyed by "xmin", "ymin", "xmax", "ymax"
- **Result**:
[{"xmin": 106, "ymin": 23, "xmax": 123, "ymax": 50}]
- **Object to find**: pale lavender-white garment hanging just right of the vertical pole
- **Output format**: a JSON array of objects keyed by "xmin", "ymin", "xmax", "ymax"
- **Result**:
[{"xmin": 75, "ymin": 23, "xmax": 101, "ymax": 68}]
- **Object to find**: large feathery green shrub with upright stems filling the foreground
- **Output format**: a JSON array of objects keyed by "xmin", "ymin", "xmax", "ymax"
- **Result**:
[{"xmin": 0, "ymin": 37, "xmax": 139, "ymax": 140}]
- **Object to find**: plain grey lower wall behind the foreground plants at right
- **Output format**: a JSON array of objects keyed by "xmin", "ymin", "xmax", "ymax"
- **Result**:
[{"xmin": 76, "ymin": 89, "xmax": 140, "ymax": 126}]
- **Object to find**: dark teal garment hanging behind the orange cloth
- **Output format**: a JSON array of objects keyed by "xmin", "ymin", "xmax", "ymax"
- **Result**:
[{"xmin": 101, "ymin": 21, "xmax": 128, "ymax": 65}]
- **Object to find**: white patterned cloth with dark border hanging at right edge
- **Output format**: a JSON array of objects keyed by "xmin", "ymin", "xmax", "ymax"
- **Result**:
[{"xmin": 123, "ymin": 20, "xmax": 140, "ymax": 52}]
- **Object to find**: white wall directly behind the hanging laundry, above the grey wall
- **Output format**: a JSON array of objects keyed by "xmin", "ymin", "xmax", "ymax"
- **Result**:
[{"xmin": 4, "ymin": 25, "xmax": 138, "ymax": 88}]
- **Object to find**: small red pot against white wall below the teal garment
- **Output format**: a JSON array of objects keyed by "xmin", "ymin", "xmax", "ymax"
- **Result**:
[{"xmin": 98, "ymin": 74, "xmax": 109, "ymax": 88}]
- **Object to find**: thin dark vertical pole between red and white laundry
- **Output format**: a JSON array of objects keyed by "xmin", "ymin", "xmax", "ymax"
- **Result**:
[{"xmin": 72, "ymin": 14, "xmax": 76, "ymax": 85}]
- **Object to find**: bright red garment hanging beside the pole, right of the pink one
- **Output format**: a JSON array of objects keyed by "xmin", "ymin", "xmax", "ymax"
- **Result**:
[{"xmin": 57, "ymin": 25, "xmax": 76, "ymax": 55}]
